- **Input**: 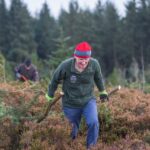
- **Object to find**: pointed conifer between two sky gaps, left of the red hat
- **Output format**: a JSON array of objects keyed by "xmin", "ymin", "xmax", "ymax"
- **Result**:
[{"xmin": 35, "ymin": 3, "xmax": 58, "ymax": 59}]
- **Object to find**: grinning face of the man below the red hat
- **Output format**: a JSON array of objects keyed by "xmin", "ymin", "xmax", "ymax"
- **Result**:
[{"xmin": 75, "ymin": 56, "xmax": 90, "ymax": 70}]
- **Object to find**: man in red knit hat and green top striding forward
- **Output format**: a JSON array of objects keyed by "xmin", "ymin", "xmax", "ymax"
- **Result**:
[{"xmin": 46, "ymin": 42, "xmax": 108, "ymax": 149}]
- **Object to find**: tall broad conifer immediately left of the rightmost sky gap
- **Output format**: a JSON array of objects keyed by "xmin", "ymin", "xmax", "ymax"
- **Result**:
[{"xmin": 93, "ymin": 0, "xmax": 119, "ymax": 75}]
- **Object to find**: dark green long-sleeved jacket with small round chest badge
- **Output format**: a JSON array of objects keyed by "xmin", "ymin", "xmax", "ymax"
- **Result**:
[{"xmin": 48, "ymin": 58, "xmax": 104, "ymax": 108}]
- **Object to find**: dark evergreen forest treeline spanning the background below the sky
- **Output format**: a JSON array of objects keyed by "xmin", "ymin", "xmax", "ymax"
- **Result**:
[{"xmin": 0, "ymin": 0, "xmax": 150, "ymax": 83}]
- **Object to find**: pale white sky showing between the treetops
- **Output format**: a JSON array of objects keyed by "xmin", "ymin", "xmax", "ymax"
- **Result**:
[{"xmin": 5, "ymin": 0, "xmax": 129, "ymax": 18}]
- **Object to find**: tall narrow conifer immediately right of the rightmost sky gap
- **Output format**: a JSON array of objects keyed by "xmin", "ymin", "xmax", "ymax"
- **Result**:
[{"xmin": 118, "ymin": 0, "xmax": 138, "ymax": 68}]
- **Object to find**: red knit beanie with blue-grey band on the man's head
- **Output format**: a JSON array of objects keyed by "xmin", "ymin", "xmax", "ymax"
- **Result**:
[{"xmin": 74, "ymin": 42, "xmax": 92, "ymax": 58}]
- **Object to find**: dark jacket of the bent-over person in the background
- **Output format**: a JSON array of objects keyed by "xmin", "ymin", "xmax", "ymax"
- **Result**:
[{"xmin": 15, "ymin": 64, "xmax": 39, "ymax": 81}]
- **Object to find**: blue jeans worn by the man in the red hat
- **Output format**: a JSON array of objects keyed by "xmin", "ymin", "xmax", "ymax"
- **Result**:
[{"xmin": 63, "ymin": 99, "xmax": 99, "ymax": 148}]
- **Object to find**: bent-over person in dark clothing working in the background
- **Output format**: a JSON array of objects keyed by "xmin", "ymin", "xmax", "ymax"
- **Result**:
[{"xmin": 15, "ymin": 58, "xmax": 39, "ymax": 81}]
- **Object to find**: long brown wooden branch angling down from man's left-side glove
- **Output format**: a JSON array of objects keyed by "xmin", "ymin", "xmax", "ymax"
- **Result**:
[{"xmin": 37, "ymin": 92, "xmax": 64, "ymax": 123}]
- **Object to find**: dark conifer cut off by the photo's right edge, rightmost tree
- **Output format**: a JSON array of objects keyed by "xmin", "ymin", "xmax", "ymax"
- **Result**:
[{"xmin": 135, "ymin": 0, "xmax": 150, "ymax": 64}]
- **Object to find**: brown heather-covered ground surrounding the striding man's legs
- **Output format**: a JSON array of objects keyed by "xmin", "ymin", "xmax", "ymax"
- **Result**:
[{"xmin": 0, "ymin": 83, "xmax": 150, "ymax": 150}]
